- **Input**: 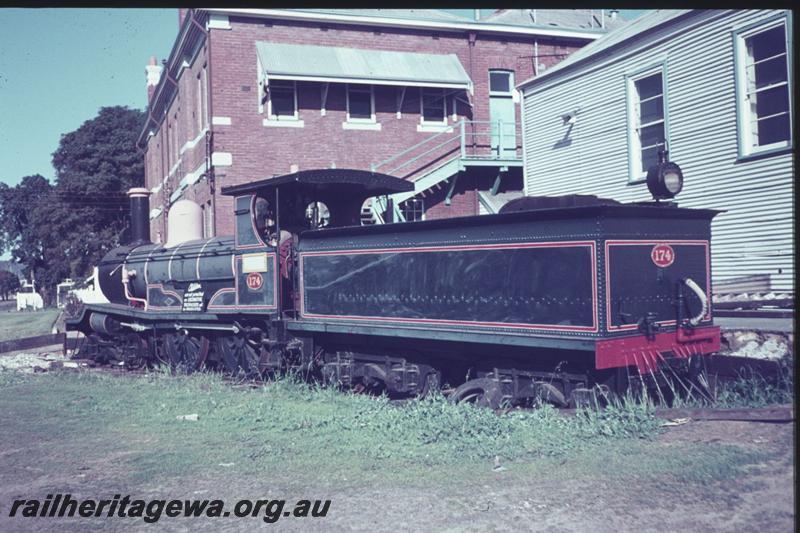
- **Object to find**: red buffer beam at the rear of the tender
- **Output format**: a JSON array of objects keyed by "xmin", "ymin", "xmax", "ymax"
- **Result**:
[{"xmin": 595, "ymin": 326, "xmax": 720, "ymax": 374}]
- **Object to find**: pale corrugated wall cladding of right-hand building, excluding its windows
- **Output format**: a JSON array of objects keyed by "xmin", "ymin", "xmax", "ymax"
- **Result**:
[{"xmin": 523, "ymin": 10, "xmax": 794, "ymax": 291}]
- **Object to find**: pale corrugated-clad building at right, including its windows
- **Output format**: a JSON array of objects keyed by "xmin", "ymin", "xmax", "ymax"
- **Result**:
[{"xmin": 519, "ymin": 9, "xmax": 796, "ymax": 290}]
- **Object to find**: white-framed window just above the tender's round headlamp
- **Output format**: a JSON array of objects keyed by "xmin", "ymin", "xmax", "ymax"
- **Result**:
[{"xmin": 627, "ymin": 64, "xmax": 668, "ymax": 183}]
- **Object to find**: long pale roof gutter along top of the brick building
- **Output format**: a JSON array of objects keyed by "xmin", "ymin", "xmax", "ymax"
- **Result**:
[{"xmin": 202, "ymin": 8, "xmax": 606, "ymax": 41}]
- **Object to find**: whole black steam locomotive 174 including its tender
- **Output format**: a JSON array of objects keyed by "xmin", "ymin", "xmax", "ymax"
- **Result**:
[{"xmin": 67, "ymin": 164, "xmax": 720, "ymax": 407}]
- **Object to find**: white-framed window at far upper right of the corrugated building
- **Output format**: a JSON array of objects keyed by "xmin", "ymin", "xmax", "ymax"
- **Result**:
[{"xmin": 734, "ymin": 16, "xmax": 792, "ymax": 157}]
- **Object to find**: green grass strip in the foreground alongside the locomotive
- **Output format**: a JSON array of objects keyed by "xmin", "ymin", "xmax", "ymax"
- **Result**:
[{"xmin": 0, "ymin": 372, "xmax": 776, "ymax": 489}]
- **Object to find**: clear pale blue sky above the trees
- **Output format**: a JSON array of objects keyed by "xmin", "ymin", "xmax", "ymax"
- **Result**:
[{"xmin": 0, "ymin": 8, "xmax": 644, "ymax": 185}]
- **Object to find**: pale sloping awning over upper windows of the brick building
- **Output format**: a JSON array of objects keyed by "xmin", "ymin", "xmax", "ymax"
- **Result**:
[{"xmin": 256, "ymin": 41, "xmax": 471, "ymax": 90}]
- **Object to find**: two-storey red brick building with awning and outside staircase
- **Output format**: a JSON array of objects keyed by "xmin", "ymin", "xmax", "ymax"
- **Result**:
[{"xmin": 139, "ymin": 9, "xmax": 622, "ymax": 242}]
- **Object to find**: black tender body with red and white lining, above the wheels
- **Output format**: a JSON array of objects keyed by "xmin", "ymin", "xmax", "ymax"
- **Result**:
[{"xmin": 290, "ymin": 205, "xmax": 716, "ymax": 349}]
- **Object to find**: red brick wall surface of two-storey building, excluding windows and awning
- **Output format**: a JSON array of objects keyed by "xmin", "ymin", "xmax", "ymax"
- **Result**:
[{"xmin": 147, "ymin": 11, "xmax": 581, "ymax": 234}]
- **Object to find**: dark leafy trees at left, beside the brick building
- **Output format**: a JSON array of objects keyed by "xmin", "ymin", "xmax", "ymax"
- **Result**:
[{"xmin": 0, "ymin": 106, "xmax": 145, "ymax": 303}]
